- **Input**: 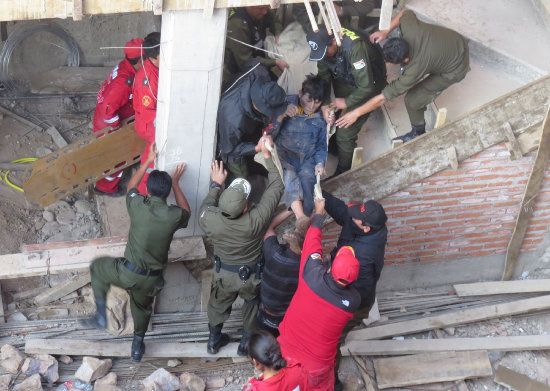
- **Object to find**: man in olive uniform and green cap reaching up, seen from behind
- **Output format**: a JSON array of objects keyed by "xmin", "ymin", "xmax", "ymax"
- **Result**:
[{"xmin": 199, "ymin": 136, "xmax": 284, "ymax": 356}]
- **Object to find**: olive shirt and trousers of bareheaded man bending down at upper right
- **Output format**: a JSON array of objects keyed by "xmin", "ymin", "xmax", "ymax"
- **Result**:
[{"xmin": 382, "ymin": 10, "xmax": 470, "ymax": 126}]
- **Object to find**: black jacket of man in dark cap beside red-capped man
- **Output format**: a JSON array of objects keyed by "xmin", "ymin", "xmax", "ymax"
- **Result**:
[{"xmin": 323, "ymin": 191, "xmax": 388, "ymax": 308}]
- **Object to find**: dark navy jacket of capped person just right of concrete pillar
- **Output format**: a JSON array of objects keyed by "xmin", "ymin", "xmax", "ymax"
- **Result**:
[{"xmin": 217, "ymin": 62, "xmax": 270, "ymax": 163}]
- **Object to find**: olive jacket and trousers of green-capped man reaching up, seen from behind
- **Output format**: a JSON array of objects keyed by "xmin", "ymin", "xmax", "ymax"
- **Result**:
[{"xmin": 199, "ymin": 159, "xmax": 284, "ymax": 334}]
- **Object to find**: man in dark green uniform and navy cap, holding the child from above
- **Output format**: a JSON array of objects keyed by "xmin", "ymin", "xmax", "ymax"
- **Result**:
[{"xmin": 306, "ymin": 26, "xmax": 386, "ymax": 175}]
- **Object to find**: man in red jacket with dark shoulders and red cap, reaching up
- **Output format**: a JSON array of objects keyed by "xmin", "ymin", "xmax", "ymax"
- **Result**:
[{"xmin": 278, "ymin": 199, "xmax": 361, "ymax": 391}]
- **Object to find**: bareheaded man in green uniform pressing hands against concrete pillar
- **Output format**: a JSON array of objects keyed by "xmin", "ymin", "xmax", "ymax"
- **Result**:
[{"xmin": 83, "ymin": 143, "xmax": 190, "ymax": 362}]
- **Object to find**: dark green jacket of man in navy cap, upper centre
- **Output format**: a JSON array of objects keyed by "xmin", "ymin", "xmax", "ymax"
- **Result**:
[{"xmin": 317, "ymin": 29, "xmax": 386, "ymax": 110}]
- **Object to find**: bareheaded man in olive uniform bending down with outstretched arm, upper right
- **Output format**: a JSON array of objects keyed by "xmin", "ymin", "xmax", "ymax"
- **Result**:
[{"xmin": 336, "ymin": 8, "xmax": 470, "ymax": 142}]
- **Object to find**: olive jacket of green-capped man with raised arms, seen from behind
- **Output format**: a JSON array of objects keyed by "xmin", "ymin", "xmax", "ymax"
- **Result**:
[{"xmin": 199, "ymin": 159, "xmax": 284, "ymax": 265}]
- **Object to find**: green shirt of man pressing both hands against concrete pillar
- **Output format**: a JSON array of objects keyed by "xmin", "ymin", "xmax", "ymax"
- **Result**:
[{"xmin": 124, "ymin": 188, "xmax": 189, "ymax": 270}]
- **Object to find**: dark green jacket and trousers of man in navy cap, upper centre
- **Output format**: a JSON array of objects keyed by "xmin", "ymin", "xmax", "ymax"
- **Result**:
[{"xmin": 317, "ymin": 29, "xmax": 386, "ymax": 174}]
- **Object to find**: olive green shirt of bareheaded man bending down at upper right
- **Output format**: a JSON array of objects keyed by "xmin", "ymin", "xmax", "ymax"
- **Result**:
[{"xmin": 382, "ymin": 10, "xmax": 469, "ymax": 100}]
